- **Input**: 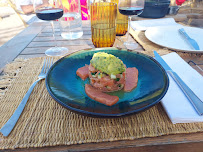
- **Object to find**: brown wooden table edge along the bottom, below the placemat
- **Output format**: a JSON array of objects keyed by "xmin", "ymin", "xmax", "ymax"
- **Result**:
[{"xmin": 2, "ymin": 133, "xmax": 203, "ymax": 152}]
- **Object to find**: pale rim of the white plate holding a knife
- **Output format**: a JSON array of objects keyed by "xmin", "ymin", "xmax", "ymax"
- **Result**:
[{"xmin": 144, "ymin": 25, "xmax": 203, "ymax": 54}]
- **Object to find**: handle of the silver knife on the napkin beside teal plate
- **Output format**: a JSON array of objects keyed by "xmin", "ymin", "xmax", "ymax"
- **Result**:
[{"xmin": 167, "ymin": 70, "xmax": 203, "ymax": 115}]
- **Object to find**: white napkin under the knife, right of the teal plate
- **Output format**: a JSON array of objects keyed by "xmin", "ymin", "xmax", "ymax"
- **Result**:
[{"xmin": 161, "ymin": 52, "xmax": 203, "ymax": 124}]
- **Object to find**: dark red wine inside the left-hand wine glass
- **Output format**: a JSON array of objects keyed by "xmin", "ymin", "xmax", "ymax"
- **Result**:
[{"xmin": 36, "ymin": 8, "xmax": 63, "ymax": 21}]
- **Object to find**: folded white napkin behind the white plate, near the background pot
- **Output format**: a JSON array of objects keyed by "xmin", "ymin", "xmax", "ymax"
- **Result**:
[{"xmin": 130, "ymin": 18, "xmax": 180, "ymax": 31}]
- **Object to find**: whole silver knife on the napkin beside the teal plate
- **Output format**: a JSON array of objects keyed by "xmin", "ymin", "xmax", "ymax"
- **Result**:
[{"xmin": 154, "ymin": 51, "xmax": 203, "ymax": 115}]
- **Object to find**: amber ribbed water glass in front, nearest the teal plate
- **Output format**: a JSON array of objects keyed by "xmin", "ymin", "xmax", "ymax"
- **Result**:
[{"xmin": 90, "ymin": 2, "xmax": 117, "ymax": 47}]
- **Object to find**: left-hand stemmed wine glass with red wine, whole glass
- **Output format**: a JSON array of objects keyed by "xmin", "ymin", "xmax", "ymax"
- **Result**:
[{"xmin": 33, "ymin": 0, "xmax": 68, "ymax": 56}]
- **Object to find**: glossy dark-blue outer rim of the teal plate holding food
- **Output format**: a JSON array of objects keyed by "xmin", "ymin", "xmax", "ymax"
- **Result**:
[{"xmin": 45, "ymin": 47, "xmax": 169, "ymax": 118}]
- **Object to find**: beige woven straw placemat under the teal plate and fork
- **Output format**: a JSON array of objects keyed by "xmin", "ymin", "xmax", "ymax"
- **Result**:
[{"xmin": 0, "ymin": 55, "xmax": 203, "ymax": 149}]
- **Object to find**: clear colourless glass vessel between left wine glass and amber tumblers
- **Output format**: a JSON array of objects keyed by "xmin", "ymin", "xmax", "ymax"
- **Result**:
[{"xmin": 59, "ymin": 0, "xmax": 83, "ymax": 40}]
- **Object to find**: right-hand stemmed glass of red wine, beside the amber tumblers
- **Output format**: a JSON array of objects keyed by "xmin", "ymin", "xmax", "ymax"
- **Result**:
[{"xmin": 118, "ymin": 0, "xmax": 145, "ymax": 49}]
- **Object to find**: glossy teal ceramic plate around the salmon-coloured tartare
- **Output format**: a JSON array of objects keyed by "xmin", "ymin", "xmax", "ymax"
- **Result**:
[{"xmin": 46, "ymin": 48, "xmax": 169, "ymax": 117}]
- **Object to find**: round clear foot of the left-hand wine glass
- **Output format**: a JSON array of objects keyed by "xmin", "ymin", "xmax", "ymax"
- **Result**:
[{"xmin": 45, "ymin": 47, "xmax": 69, "ymax": 56}]
